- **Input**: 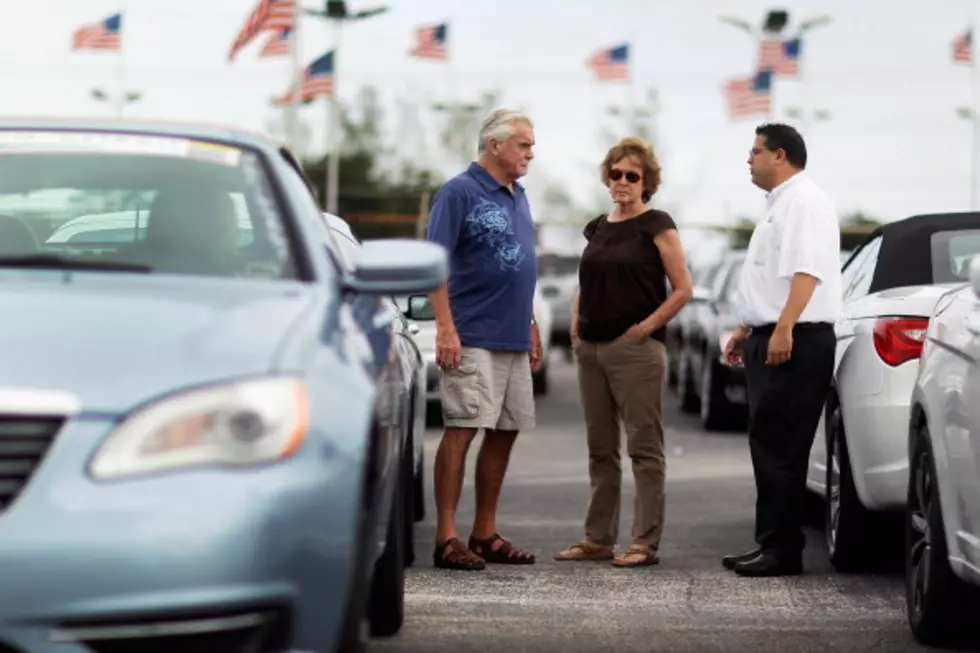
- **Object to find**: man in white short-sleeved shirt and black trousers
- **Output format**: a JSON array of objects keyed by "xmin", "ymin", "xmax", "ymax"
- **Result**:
[{"xmin": 722, "ymin": 124, "xmax": 841, "ymax": 576}]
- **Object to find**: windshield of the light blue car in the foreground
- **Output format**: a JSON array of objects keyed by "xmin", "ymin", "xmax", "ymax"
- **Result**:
[{"xmin": 0, "ymin": 131, "xmax": 297, "ymax": 279}]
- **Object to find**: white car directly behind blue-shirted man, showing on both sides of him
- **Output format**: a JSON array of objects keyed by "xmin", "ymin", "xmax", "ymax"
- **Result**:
[{"xmin": 398, "ymin": 288, "xmax": 552, "ymax": 425}]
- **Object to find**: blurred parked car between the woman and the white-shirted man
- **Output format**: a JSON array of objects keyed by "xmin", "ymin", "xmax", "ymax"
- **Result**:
[{"xmin": 677, "ymin": 250, "xmax": 748, "ymax": 430}]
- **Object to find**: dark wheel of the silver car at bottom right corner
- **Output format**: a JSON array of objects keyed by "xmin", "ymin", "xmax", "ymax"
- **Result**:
[{"xmin": 905, "ymin": 426, "xmax": 980, "ymax": 646}]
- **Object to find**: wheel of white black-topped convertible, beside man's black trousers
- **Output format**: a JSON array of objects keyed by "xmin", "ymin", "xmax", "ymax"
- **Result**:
[{"xmin": 824, "ymin": 404, "xmax": 874, "ymax": 572}]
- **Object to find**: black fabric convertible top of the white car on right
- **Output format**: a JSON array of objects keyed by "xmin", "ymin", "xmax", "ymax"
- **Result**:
[{"xmin": 860, "ymin": 212, "xmax": 980, "ymax": 293}]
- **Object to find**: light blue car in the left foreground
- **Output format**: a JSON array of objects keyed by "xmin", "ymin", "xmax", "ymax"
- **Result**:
[{"xmin": 0, "ymin": 120, "xmax": 448, "ymax": 653}]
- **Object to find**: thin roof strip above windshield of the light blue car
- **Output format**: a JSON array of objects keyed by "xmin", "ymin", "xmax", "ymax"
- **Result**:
[{"xmin": 0, "ymin": 116, "xmax": 282, "ymax": 149}]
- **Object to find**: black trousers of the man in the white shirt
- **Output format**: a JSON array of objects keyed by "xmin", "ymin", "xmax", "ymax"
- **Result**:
[{"xmin": 742, "ymin": 323, "xmax": 836, "ymax": 559}]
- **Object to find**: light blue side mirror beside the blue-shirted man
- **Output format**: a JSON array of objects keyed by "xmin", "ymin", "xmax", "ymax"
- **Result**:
[{"xmin": 344, "ymin": 238, "xmax": 449, "ymax": 296}]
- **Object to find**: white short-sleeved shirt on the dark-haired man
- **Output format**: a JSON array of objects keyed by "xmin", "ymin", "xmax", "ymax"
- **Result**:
[{"xmin": 735, "ymin": 171, "xmax": 842, "ymax": 327}]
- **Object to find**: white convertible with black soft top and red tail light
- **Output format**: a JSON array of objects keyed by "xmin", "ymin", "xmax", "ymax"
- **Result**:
[{"xmin": 807, "ymin": 213, "xmax": 980, "ymax": 571}]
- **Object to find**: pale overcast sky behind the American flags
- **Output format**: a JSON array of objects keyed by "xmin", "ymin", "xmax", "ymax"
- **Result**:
[{"xmin": 0, "ymin": 0, "xmax": 980, "ymax": 253}]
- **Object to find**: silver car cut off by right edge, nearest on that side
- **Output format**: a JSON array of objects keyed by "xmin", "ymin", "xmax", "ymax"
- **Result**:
[{"xmin": 905, "ymin": 255, "xmax": 980, "ymax": 648}]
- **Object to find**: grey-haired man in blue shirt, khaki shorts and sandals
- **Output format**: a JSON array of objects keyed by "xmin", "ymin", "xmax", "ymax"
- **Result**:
[{"xmin": 428, "ymin": 109, "xmax": 542, "ymax": 570}]
